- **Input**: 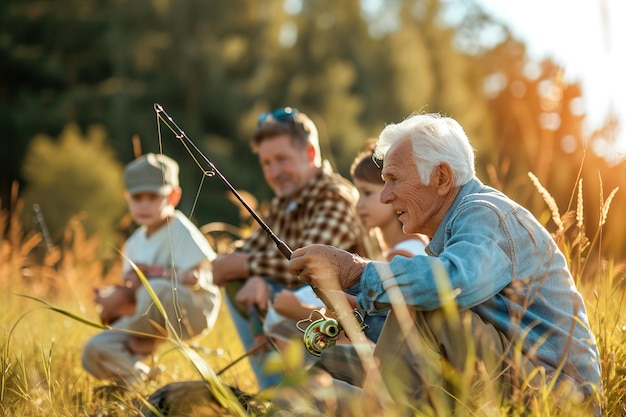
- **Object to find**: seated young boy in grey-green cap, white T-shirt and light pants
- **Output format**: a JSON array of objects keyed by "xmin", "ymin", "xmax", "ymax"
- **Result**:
[{"xmin": 83, "ymin": 154, "xmax": 221, "ymax": 386}]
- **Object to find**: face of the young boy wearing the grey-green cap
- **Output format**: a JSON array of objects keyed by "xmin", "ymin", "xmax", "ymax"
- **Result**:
[{"xmin": 126, "ymin": 192, "xmax": 172, "ymax": 234}]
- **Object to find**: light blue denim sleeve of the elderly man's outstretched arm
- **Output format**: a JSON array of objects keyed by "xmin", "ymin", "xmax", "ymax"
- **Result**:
[{"xmin": 357, "ymin": 202, "xmax": 514, "ymax": 312}]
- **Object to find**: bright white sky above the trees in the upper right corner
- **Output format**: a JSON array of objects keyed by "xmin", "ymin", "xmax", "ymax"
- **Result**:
[{"xmin": 478, "ymin": 0, "xmax": 626, "ymax": 158}]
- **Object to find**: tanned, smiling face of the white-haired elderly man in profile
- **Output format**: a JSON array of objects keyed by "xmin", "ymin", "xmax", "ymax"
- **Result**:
[{"xmin": 380, "ymin": 140, "xmax": 444, "ymax": 237}]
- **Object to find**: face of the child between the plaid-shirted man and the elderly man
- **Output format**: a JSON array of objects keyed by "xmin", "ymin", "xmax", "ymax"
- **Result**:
[{"xmin": 354, "ymin": 178, "xmax": 398, "ymax": 230}]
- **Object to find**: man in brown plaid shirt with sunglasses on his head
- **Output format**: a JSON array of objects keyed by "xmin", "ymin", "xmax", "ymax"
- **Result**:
[{"xmin": 213, "ymin": 107, "xmax": 363, "ymax": 389}]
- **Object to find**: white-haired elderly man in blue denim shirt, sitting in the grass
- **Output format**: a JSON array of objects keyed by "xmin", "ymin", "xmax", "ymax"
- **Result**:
[{"xmin": 290, "ymin": 114, "xmax": 602, "ymax": 415}]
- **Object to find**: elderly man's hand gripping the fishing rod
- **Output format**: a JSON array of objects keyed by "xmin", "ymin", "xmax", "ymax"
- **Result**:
[{"xmin": 289, "ymin": 245, "xmax": 369, "ymax": 290}]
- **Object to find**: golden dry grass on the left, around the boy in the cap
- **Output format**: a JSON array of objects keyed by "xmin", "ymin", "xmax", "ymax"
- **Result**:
[{"xmin": 0, "ymin": 203, "xmax": 257, "ymax": 417}]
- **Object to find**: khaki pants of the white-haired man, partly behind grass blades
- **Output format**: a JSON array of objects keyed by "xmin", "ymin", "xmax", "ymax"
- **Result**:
[{"xmin": 364, "ymin": 310, "xmax": 520, "ymax": 416}]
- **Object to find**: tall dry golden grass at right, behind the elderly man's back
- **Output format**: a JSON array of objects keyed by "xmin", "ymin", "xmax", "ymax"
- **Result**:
[{"xmin": 529, "ymin": 172, "xmax": 626, "ymax": 416}]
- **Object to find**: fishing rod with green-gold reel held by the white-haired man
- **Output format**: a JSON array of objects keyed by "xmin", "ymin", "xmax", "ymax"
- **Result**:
[{"xmin": 154, "ymin": 103, "xmax": 367, "ymax": 356}]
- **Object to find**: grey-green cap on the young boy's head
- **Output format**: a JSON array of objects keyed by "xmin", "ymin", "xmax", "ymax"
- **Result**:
[{"xmin": 124, "ymin": 153, "xmax": 178, "ymax": 195}]
